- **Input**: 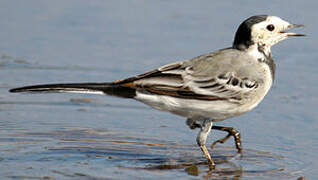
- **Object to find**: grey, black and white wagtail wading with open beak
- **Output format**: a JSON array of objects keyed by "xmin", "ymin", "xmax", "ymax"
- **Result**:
[{"xmin": 9, "ymin": 15, "xmax": 305, "ymax": 170}]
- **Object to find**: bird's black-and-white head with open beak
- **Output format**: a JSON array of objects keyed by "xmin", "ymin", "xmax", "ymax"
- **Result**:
[{"xmin": 233, "ymin": 15, "xmax": 304, "ymax": 50}]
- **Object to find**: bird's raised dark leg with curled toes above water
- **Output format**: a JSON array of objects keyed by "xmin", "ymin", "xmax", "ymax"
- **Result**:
[{"xmin": 211, "ymin": 126, "xmax": 242, "ymax": 153}]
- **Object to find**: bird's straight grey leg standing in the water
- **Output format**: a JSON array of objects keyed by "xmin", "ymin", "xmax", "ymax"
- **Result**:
[{"xmin": 197, "ymin": 119, "xmax": 215, "ymax": 170}]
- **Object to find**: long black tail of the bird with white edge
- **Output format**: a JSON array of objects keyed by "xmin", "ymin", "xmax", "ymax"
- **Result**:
[{"xmin": 9, "ymin": 83, "xmax": 136, "ymax": 98}]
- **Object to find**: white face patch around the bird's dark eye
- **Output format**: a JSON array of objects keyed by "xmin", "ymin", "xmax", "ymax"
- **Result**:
[{"xmin": 251, "ymin": 16, "xmax": 291, "ymax": 49}]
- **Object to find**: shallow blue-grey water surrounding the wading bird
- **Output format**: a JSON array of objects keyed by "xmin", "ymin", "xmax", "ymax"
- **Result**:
[{"xmin": 0, "ymin": 0, "xmax": 318, "ymax": 179}]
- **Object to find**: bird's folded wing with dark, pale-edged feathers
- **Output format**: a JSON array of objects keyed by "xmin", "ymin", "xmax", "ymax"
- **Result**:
[{"xmin": 115, "ymin": 57, "xmax": 258, "ymax": 101}]
